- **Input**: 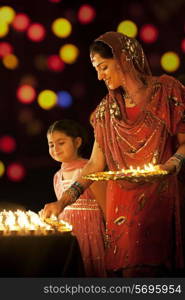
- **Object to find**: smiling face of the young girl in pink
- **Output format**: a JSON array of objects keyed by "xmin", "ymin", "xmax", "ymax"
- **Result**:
[{"xmin": 47, "ymin": 131, "xmax": 82, "ymax": 162}]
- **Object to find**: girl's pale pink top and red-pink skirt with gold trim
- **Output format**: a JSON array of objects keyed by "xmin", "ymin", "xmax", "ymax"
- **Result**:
[{"xmin": 54, "ymin": 159, "xmax": 106, "ymax": 277}]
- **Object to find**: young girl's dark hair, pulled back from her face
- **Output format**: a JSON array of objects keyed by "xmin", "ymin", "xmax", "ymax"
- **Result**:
[{"xmin": 47, "ymin": 119, "xmax": 88, "ymax": 155}]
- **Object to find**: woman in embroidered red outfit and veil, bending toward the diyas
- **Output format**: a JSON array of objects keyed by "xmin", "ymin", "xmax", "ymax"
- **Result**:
[{"xmin": 43, "ymin": 32, "xmax": 185, "ymax": 277}]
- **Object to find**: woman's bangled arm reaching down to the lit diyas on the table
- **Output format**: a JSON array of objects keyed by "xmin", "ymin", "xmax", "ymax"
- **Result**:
[{"xmin": 41, "ymin": 141, "xmax": 106, "ymax": 218}]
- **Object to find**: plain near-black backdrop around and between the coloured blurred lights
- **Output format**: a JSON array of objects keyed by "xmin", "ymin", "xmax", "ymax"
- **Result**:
[{"xmin": 0, "ymin": 0, "xmax": 185, "ymax": 211}]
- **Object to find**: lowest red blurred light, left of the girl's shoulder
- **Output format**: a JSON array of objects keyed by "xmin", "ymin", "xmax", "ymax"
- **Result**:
[{"xmin": 7, "ymin": 163, "xmax": 26, "ymax": 181}]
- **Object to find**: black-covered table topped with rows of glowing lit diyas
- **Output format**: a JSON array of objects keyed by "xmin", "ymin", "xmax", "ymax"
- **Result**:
[{"xmin": 0, "ymin": 207, "xmax": 85, "ymax": 278}]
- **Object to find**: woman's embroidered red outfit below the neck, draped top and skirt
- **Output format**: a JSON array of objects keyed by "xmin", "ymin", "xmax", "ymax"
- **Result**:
[{"xmin": 93, "ymin": 33, "xmax": 185, "ymax": 270}]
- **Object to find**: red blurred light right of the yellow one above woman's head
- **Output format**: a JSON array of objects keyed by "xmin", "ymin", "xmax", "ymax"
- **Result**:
[{"xmin": 140, "ymin": 24, "xmax": 159, "ymax": 43}]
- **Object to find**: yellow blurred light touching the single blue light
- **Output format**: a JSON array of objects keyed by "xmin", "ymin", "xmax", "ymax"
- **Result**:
[{"xmin": 37, "ymin": 90, "xmax": 57, "ymax": 110}]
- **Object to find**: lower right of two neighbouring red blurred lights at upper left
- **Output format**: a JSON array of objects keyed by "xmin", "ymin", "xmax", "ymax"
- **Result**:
[{"xmin": 27, "ymin": 23, "xmax": 46, "ymax": 42}]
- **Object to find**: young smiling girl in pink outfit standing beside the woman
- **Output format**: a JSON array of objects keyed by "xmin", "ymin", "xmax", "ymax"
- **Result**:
[{"xmin": 47, "ymin": 120, "xmax": 106, "ymax": 277}]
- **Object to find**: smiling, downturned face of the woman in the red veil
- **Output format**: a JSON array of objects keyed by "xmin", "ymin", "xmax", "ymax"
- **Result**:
[{"xmin": 91, "ymin": 53, "xmax": 123, "ymax": 90}]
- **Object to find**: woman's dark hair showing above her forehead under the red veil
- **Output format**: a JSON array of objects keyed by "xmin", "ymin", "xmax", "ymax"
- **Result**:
[{"xmin": 89, "ymin": 41, "xmax": 113, "ymax": 58}]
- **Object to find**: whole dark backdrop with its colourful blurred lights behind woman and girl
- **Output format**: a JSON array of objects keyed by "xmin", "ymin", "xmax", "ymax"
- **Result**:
[{"xmin": 0, "ymin": 0, "xmax": 185, "ymax": 210}]
